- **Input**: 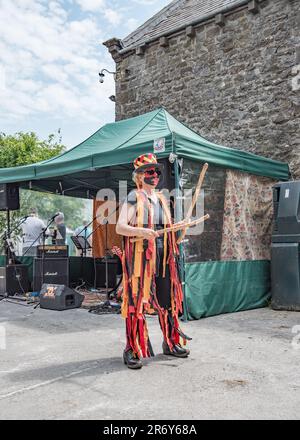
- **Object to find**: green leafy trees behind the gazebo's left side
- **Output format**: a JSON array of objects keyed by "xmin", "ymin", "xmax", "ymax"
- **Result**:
[{"xmin": 0, "ymin": 132, "xmax": 87, "ymax": 251}]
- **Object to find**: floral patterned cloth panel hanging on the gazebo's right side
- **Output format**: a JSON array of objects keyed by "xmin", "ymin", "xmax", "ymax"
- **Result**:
[{"xmin": 220, "ymin": 170, "xmax": 275, "ymax": 260}]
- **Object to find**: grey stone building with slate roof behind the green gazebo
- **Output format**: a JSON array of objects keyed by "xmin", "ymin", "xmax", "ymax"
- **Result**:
[{"xmin": 104, "ymin": 0, "xmax": 300, "ymax": 179}]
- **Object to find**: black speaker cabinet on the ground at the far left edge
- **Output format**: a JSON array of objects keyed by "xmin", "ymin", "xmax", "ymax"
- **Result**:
[{"xmin": 0, "ymin": 264, "xmax": 29, "ymax": 295}]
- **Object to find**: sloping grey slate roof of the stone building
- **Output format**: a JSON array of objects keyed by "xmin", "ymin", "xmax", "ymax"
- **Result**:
[{"xmin": 122, "ymin": 0, "xmax": 246, "ymax": 49}]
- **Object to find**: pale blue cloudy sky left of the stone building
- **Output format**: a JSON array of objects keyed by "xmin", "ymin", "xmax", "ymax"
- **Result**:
[{"xmin": 0, "ymin": 0, "xmax": 171, "ymax": 148}]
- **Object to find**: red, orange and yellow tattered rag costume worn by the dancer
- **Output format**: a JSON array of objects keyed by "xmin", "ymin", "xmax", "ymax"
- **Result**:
[{"xmin": 122, "ymin": 190, "xmax": 186, "ymax": 357}]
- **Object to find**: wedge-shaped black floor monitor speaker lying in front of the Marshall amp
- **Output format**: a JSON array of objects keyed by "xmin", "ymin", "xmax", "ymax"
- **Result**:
[{"xmin": 40, "ymin": 284, "xmax": 84, "ymax": 310}]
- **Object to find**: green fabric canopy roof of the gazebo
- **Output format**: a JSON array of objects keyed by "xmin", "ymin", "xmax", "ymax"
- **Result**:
[{"xmin": 0, "ymin": 108, "xmax": 289, "ymax": 197}]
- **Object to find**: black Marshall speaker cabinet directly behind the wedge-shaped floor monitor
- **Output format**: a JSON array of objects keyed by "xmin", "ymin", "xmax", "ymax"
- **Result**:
[{"xmin": 33, "ymin": 258, "xmax": 69, "ymax": 292}]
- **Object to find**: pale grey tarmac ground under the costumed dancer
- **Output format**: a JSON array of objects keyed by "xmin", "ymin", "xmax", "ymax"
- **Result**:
[{"xmin": 0, "ymin": 300, "xmax": 300, "ymax": 420}]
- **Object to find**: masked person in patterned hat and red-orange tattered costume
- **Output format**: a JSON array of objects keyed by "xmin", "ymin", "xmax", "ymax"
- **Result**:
[{"xmin": 116, "ymin": 153, "xmax": 190, "ymax": 369}]
